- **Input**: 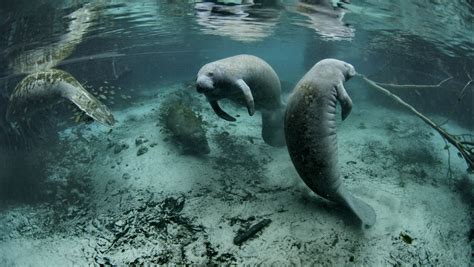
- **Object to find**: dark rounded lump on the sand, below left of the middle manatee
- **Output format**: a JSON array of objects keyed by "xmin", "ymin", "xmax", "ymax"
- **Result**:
[{"xmin": 160, "ymin": 101, "xmax": 211, "ymax": 155}]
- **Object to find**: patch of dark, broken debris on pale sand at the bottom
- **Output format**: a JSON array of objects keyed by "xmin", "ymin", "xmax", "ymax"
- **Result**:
[{"xmin": 92, "ymin": 195, "xmax": 218, "ymax": 265}]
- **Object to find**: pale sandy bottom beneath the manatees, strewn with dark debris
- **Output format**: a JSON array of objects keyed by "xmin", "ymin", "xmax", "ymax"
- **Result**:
[{"xmin": 0, "ymin": 84, "xmax": 474, "ymax": 266}]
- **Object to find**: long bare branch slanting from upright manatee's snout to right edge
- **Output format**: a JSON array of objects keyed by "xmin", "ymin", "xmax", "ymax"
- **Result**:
[{"xmin": 357, "ymin": 74, "xmax": 474, "ymax": 172}]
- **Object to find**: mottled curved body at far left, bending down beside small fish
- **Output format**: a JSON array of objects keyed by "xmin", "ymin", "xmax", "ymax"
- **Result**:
[{"xmin": 6, "ymin": 69, "xmax": 115, "ymax": 126}]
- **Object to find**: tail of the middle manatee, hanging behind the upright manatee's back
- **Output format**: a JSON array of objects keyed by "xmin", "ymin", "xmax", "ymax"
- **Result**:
[{"xmin": 262, "ymin": 106, "xmax": 286, "ymax": 147}]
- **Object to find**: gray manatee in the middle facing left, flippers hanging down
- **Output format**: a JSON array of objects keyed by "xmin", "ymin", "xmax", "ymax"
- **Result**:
[{"xmin": 196, "ymin": 55, "xmax": 285, "ymax": 147}]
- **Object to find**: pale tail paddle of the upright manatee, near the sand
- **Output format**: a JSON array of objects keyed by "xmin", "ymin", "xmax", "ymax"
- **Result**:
[{"xmin": 340, "ymin": 187, "xmax": 377, "ymax": 228}]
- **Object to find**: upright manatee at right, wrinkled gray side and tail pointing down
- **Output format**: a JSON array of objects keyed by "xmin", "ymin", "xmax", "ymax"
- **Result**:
[{"xmin": 285, "ymin": 59, "xmax": 376, "ymax": 227}]
